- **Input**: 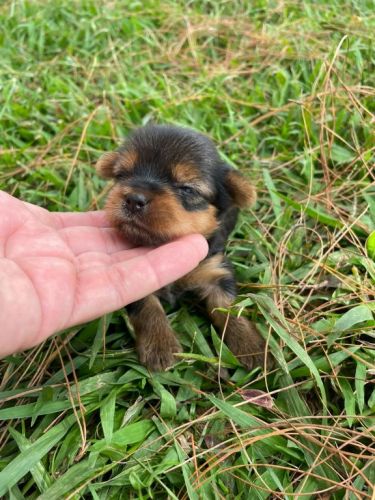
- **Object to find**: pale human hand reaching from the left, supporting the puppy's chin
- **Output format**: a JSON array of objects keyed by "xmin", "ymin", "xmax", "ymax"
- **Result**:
[{"xmin": 0, "ymin": 191, "xmax": 207, "ymax": 357}]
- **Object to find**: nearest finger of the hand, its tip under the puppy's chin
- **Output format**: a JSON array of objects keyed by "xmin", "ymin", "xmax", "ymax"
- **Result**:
[{"xmin": 65, "ymin": 234, "xmax": 208, "ymax": 327}]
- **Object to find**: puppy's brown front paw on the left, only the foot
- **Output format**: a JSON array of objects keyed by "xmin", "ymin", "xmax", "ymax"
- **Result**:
[{"xmin": 137, "ymin": 330, "xmax": 182, "ymax": 372}]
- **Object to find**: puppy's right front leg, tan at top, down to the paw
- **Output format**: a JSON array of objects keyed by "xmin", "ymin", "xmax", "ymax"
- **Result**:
[{"xmin": 183, "ymin": 254, "xmax": 266, "ymax": 370}]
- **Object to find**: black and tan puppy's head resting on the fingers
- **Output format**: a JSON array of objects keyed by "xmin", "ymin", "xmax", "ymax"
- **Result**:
[{"xmin": 96, "ymin": 125, "xmax": 255, "ymax": 246}]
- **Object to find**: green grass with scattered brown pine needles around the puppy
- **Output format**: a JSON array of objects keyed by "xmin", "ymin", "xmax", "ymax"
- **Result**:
[{"xmin": 0, "ymin": 0, "xmax": 375, "ymax": 500}]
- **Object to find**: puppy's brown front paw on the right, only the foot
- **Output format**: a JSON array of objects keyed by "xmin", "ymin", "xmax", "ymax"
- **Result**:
[{"xmin": 225, "ymin": 317, "xmax": 273, "ymax": 371}]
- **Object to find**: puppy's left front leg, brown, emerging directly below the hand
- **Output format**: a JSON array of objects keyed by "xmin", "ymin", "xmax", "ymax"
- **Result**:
[{"xmin": 126, "ymin": 295, "xmax": 181, "ymax": 371}]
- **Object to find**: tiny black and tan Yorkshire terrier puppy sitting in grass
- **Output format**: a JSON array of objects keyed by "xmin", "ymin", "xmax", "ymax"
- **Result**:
[{"xmin": 97, "ymin": 125, "xmax": 265, "ymax": 371}]
